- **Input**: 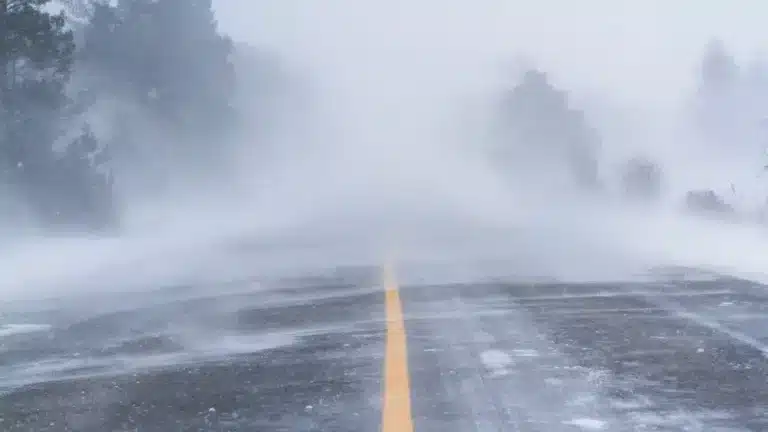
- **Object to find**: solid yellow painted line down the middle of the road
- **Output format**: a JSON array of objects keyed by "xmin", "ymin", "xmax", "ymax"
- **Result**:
[{"xmin": 381, "ymin": 266, "xmax": 413, "ymax": 432}]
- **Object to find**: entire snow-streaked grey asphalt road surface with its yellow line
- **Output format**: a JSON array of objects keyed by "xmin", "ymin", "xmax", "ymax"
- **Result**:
[{"xmin": 0, "ymin": 268, "xmax": 768, "ymax": 432}]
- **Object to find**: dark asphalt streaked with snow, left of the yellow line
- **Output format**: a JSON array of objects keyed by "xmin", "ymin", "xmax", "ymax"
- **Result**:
[{"xmin": 0, "ymin": 274, "xmax": 384, "ymax": 432}]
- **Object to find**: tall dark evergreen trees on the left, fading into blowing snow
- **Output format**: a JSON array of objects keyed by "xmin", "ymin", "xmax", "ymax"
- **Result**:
[{"xmin": 0, "ymin": 0, "xmax": 255, "ymax": 233}]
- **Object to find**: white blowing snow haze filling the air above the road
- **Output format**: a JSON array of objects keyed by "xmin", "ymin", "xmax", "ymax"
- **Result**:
[{"xmin": 6, "ymin": 0, "xmax": 768, "ymax": 306}]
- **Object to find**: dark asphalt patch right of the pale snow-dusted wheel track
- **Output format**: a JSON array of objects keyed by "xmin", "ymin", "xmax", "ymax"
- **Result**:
[{"xmin": 504, "ymin": 279, "xmax": 768, "ymax": 431}]
